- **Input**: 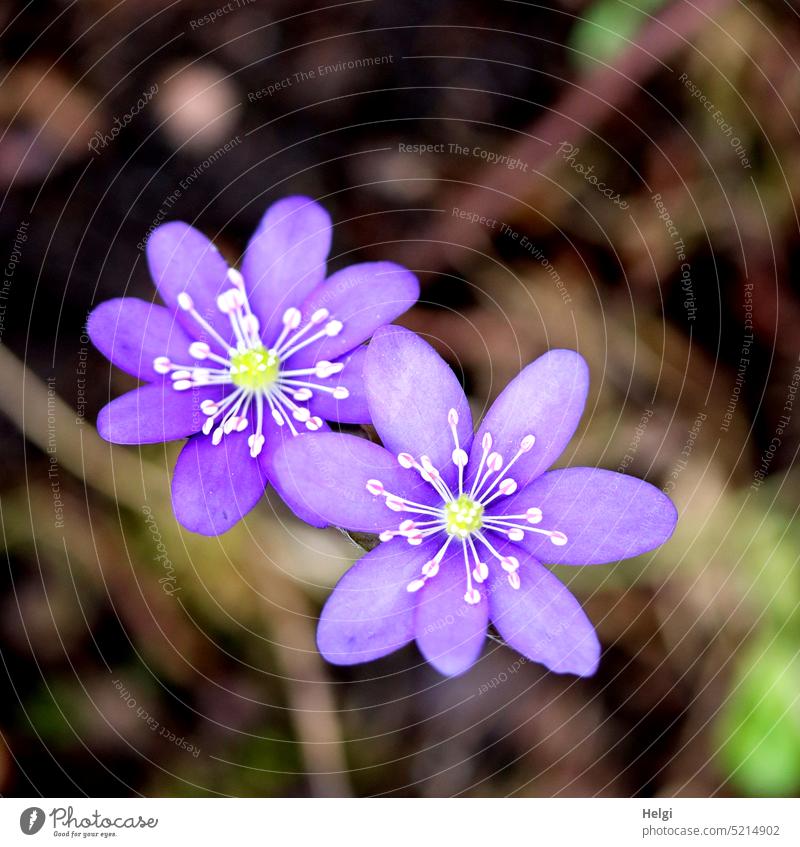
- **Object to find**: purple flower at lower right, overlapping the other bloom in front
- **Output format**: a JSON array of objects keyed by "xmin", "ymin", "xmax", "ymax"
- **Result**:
[{"xmin": 274, "ymin": 327, "xmax": 677, "ymax": 676}]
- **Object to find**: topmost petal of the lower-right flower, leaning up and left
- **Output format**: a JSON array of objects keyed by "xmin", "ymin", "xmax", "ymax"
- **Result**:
[{"xmin": 364, "ymin": 326, "xmax": 472, "ymax": 486}]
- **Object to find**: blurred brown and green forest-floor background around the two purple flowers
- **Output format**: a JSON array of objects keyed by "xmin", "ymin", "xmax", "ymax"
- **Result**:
[{"xmin": 0, "ymin": 0, "xmax": 800, "ymax": 796}]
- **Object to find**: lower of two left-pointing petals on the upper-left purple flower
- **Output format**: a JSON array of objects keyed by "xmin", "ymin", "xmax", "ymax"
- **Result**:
[{"xmin": 97, "ymin": 381, "xmax": 222, "ymax": 444}]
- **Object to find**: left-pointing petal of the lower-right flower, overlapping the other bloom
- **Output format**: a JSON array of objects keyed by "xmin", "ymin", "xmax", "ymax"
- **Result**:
[{"xmin": 270, "ymin": 432, "xmax": 434, "ymax": 532}]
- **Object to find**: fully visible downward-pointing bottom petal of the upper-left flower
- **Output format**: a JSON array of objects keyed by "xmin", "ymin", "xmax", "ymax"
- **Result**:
[{"xmin": 172, "ymin": 430, "xmax": 267, "ymax": 535}]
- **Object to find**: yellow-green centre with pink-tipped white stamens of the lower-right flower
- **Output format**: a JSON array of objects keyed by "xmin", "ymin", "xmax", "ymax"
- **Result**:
[{"xmin": 366, "ymin": 409, "xmax": 568, "ymax": 605}]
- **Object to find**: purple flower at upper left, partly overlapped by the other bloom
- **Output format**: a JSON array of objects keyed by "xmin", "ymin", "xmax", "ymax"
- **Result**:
[{"xmin": 88, "ymin": 197, "xmax": 419, "ymax": 535}]
